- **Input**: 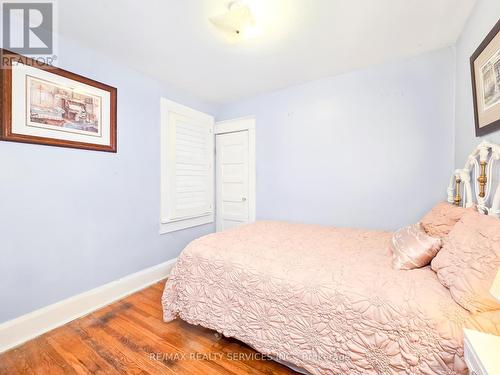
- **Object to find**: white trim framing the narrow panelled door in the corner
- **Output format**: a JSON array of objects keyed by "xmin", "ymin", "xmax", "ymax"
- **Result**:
[{"xmin": 214, "ymin": 116, "xmax": 257, "ymax": 232}]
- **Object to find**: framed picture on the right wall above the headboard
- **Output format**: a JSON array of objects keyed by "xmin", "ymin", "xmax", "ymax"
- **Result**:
[{"xmin": 470, "ymin": 20, "xmax": 500, "ymax": 137}]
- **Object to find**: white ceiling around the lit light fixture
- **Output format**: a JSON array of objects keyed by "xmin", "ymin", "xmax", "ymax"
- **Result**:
[{"xmin": 58, "ymin": 0, "xmax": 476, "ymax": 104}]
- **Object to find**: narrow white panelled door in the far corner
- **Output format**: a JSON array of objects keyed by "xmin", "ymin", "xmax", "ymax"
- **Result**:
[{"xmin": 215, "ymin": 122, "xmax": 255, "ymax": 231}]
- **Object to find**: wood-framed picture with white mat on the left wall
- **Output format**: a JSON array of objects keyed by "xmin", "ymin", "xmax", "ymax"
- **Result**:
[{"xmin": 0, "ymin": 50, "xmax": 117, "ymax": 152}]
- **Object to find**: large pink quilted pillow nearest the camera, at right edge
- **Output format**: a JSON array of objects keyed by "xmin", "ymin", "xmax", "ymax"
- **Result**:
[{"xmin": 431, "ymin": 210, "xmax": 500, "ymax": 313}]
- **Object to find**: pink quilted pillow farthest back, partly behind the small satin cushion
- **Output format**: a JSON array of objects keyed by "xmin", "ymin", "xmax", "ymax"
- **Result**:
[{"xmin": 421, "ymin": 202, "xmax": 470, "ymax": 238}]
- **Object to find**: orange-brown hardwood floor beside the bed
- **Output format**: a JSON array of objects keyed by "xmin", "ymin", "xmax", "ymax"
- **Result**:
[{"xmin": 0, "ymin": 282, "xmax": 295, "ymax": 375}]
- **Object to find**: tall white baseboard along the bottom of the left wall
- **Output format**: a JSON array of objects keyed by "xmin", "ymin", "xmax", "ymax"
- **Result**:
[{"xmin": 0, "ymin": 258, "xmax": 177, "ymax": 353}]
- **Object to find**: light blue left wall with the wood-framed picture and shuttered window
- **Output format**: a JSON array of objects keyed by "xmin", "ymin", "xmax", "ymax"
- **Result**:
[{"xmin": 0, "ymin": 38, "xmax": 216, "ymax": 322}]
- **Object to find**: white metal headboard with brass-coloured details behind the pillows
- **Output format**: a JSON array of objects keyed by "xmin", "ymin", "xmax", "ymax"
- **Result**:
[{"xmin": 448, "ymin": 141, "xmax": 500, "ymax": 217}]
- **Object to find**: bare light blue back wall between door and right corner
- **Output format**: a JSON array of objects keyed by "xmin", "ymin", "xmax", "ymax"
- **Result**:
[{"xmin": 218, "ymin": 48, "xmax": 454, "ymax": 229}]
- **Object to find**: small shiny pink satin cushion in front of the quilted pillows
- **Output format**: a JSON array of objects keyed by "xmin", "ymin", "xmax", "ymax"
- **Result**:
[{"xmin": 392, "ymin": 223, "xmax": 441, "ymax": 270}]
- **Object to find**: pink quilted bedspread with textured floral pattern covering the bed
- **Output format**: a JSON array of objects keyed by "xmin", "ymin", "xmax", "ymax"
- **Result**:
[{"xmin": 162, "ymin": 222, "xmax": 500, "ymax": 375}]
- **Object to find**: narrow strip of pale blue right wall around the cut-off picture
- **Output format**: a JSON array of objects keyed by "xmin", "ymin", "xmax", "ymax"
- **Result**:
[{"xmin": 455, "ymin": 0, "xmax": 500, "ymax": 168}]
